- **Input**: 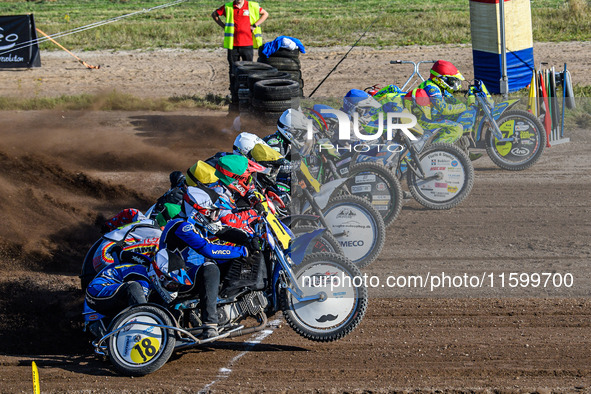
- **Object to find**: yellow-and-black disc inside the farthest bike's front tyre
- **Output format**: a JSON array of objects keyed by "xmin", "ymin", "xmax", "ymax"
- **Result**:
[{"xmin": 490, "ymin": 116, "xmax": 540, "ymax": 165}]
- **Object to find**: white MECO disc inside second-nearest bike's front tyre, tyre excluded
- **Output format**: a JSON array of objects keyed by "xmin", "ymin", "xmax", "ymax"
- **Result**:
[{"xmin": 324, "ymin": 203, "xmax": 377, "ymax": 262}]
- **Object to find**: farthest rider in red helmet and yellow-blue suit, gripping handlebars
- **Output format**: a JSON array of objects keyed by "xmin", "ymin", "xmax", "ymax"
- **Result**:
[{"xmin": 419, "ymin": 60, "xmax": 480, "ymax": 159}]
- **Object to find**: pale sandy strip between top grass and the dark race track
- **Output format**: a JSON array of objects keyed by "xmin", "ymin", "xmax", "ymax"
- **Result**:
[{"xmin": 0, "ymin": 42, "xmax": 591, "ymax": 98}]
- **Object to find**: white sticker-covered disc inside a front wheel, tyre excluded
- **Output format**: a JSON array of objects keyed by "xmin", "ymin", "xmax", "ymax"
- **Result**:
[{"xmin": 415, "ymin": 150, "xmax": 466, "ymax": 203}]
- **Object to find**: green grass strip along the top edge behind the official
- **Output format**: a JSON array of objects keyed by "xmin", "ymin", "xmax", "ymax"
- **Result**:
[{"xmin": 0, "ymin": 0, "xmax": 591, "ymax": 50}]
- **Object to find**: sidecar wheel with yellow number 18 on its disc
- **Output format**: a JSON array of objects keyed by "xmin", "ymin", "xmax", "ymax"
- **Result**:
[{"xmin": 108, "ymin": 305, "xmax": 175, "ymax": 376}]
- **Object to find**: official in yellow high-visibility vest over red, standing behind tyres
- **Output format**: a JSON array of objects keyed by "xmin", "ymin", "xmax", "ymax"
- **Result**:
[{"xmin": 211, "ymin": 0, "xmax": 269, "ymax": 112}]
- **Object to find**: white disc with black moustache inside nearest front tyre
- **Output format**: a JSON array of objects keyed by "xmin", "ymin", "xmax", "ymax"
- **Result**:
[{"xmin": 289, "ymin": 262, "xmax": 361, "ymax": 333}]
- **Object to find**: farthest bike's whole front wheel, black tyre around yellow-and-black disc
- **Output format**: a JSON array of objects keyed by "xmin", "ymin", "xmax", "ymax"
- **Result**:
[{"xmin": 485, "ymin": 110, "xmax": 546, "ymax": 171}]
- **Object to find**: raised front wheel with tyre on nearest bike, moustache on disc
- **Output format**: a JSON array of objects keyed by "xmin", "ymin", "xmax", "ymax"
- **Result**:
[{"xmin": 281, "ymin": 253, "xmax": 368, "ymax": 342}]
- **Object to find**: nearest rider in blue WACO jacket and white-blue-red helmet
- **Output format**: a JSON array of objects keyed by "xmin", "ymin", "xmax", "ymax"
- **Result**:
[{"xmin": 158, "ymin": 186, "xmax": 249, "ymax": 339}]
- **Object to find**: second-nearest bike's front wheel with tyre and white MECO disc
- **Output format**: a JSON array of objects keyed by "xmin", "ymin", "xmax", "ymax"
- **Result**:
[{"xmin": 322, "ymin": 196, "xmax": 386, "ymax": 268}]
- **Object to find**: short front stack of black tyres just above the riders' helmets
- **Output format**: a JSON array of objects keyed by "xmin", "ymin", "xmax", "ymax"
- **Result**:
[{"xmin": 251, "ymin": 79, "xmax": 300, "ymax": 125}]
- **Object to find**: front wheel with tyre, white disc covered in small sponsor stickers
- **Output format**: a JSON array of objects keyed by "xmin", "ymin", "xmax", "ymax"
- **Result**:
[{"xmin": 406, "ymin": 143, "xmax": 474, "ymax": 209}]
